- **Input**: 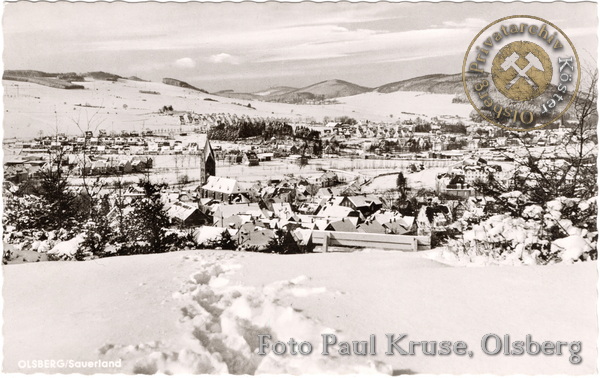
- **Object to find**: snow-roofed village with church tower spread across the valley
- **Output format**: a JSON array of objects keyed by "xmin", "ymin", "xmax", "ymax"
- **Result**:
[{"xmin": 4, "ymin": 99, "xmax": 592, "ymax": 259}]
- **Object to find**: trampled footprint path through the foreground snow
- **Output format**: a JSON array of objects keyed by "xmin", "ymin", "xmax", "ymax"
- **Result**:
[{"xmin": 100, "ymin": 254, "xmax": 392, "ymax": 374}]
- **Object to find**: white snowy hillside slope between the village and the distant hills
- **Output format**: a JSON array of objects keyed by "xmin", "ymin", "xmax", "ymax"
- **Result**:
[{"xmin": 2, "ymin": 80, "xmax": 472, "ymax": 138}]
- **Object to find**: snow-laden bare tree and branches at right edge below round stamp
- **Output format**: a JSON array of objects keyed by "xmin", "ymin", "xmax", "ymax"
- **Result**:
[{"xmin": 475, "ymin": 63, "xmax": 598, "ymax": 259}]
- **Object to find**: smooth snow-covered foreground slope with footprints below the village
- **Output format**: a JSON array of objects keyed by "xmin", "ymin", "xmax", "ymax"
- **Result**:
[{"xmin": 3, "ymin": 251, "xmax": 597, "ymax": 374}]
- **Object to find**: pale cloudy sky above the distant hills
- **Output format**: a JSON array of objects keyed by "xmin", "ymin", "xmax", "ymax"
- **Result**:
[{"xmin": 3, "ymin": 2, "xmax": 597, "ymax": 91}]
